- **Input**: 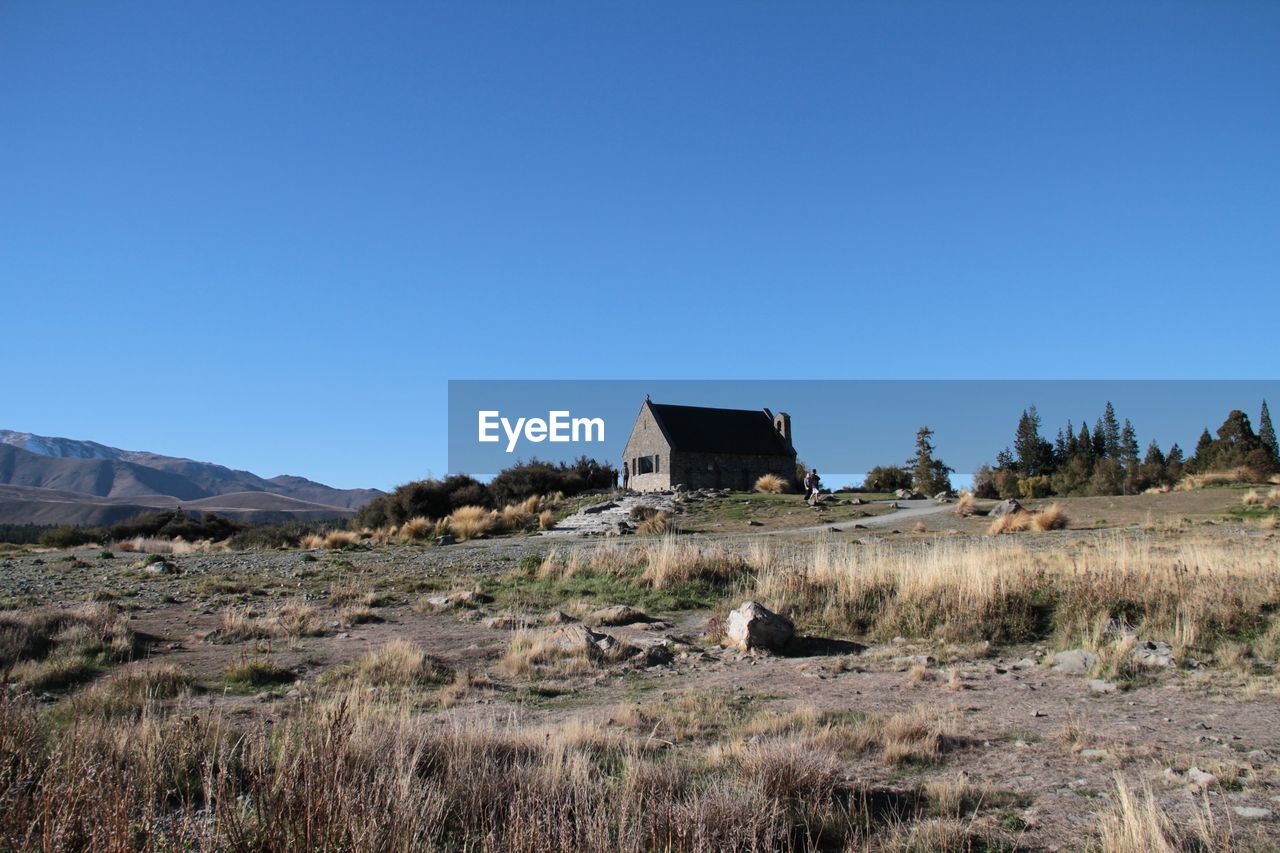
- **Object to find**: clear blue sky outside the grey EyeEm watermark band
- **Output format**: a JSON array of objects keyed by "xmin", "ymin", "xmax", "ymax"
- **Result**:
[{"xmin": 0, "ymin": 0, "xmax": 1280, "ymax": 487}]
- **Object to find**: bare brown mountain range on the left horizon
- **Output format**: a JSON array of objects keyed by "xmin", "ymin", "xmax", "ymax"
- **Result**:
[{"xmin": 0, "ymin": 429, "xmax": 381, "ymax": 525}]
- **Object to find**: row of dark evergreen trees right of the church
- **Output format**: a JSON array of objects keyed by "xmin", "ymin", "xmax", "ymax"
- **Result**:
[{"xmin": 974, "ymin": 400, "xmax": 1280, "ymax": 498}]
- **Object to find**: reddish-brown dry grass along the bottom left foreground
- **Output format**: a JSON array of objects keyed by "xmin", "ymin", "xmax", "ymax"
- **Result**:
[{"xmin": 0, "ymin": 681, "xmax": 1008, "ymax": 853}]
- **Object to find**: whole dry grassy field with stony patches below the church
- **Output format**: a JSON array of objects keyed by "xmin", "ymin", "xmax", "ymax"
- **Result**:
[{"xmin": 0, "ymin": 489, "xmax": 1280, "ymax": 850}]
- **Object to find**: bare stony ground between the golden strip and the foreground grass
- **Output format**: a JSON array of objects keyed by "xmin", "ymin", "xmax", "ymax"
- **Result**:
[{"xmin": 0, "ymin": 497, "xmax": 1280, "ymax": 849}]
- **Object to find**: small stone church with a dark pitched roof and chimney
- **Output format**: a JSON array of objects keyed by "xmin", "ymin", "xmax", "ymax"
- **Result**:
[{"xmin": 622, "ymin": 397, "xmax": 796, "ymax": 492}]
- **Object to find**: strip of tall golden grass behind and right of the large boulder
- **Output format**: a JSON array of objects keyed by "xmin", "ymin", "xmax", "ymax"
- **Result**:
[{"xmin": 749, "ymin": 533, "xmax": 1280, "ymax": 649}]
